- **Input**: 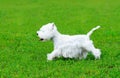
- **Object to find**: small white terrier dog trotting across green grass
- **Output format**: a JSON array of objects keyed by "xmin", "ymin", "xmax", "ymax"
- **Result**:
[{"xmin": 37, "ymin": 23, "xmax": 101, "ymax": 60}]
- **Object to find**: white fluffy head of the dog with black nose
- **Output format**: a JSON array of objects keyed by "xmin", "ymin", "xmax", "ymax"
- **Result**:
[{"xmin": 37, "ymin": 23, "xmax": 57, "ymax": 41}]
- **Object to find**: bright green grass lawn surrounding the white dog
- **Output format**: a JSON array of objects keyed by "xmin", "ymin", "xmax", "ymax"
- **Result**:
[{"xmin": 0, "ymin": 0, "xmax": 120, "ymax": 78}]
